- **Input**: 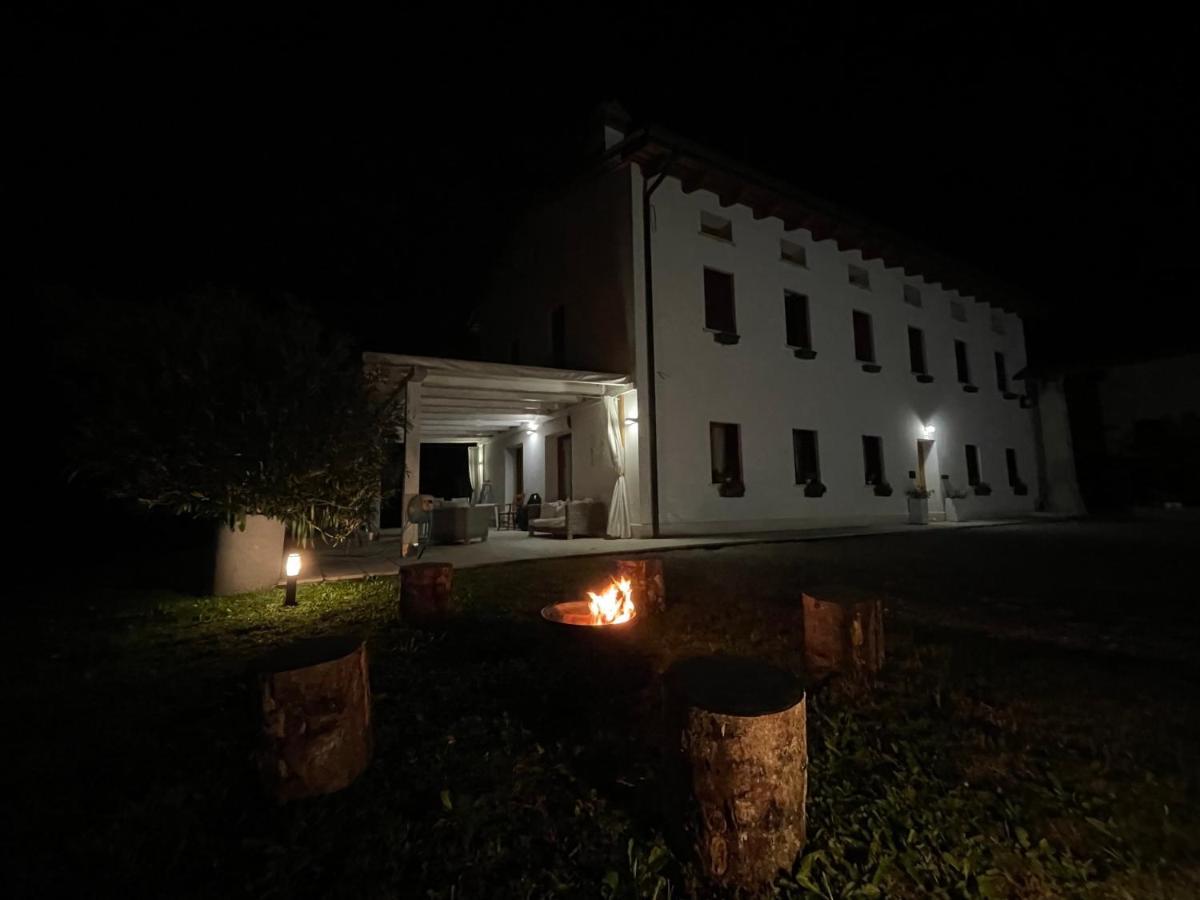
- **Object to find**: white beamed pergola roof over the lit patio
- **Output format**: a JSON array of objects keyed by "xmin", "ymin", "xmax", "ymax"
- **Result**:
[{"xmin": 362, "ymin": 353, "xmax": 632, "ymax": 444}]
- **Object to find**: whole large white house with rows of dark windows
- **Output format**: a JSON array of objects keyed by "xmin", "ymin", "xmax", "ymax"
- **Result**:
[{"xmin": 369, "ymin": 105, "xmax": 1075, "ymax": 536}]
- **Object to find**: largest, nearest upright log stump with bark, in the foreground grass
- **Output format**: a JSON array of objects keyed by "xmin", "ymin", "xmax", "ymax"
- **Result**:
[{"xmin": 665, "ymin": 656, "xmax": 809, "ymax": 889}]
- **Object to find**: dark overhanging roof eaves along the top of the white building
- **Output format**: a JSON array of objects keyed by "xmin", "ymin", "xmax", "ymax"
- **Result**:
[{"xmin": 606, "ymin": 108, "xmax": 1036, "ymax": 314}]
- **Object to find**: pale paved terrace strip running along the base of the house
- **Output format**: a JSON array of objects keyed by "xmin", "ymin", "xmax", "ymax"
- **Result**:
[{"xmin": 300, "ymin": 517, "xmax": 1040, "ymax": 583}]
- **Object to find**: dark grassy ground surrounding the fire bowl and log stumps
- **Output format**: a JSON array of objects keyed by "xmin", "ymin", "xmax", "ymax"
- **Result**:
[{"xmin": 4, "ymin": 523, "xmax": 1200, "ymax": 898}]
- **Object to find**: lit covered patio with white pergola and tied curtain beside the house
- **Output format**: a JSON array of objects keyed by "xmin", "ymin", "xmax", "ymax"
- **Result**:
[{"xmin": 364, "ymin": 353, "xmax": 638, "ymax": 558}]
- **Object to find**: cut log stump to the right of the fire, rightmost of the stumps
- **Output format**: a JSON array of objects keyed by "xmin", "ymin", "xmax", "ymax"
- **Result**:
[{"xmin": 804, "ymin": 587, "xmax": 883, "ymax": 680}]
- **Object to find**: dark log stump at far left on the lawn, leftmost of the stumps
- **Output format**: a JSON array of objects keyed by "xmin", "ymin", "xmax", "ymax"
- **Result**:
[{"xmin": 253, "ymin": 637, "xmax": 372, "ymax": 803}]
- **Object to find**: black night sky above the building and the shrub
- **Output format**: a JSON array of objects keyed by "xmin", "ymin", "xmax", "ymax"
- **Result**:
[{"xmin": 9, "ymin": 4, "xmax": 1200, "ymax": 367}]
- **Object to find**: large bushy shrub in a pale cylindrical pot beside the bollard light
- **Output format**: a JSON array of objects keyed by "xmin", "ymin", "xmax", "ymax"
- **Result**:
[{"xmin": 64, "ymin": 292, "xmax": 401, "ymax": 594}]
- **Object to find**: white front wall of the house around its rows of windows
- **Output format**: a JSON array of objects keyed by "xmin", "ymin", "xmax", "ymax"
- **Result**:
[{"xmin": 631, "ymin": 174, "xmax": 1037, "ymax": 533}]
